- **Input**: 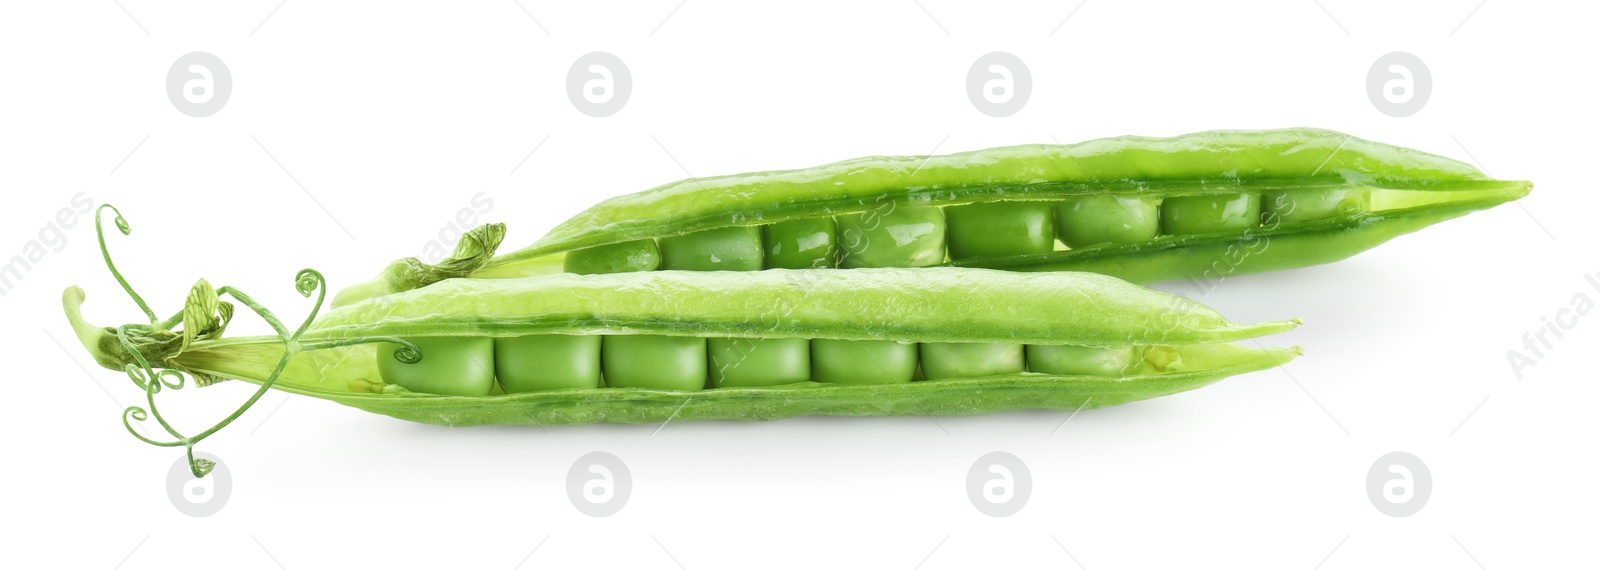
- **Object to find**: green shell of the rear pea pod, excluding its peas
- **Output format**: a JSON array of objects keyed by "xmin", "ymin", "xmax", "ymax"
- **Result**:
[{"xmin": 475, "ymin": 128, "xmax": 1531, "ymax": 282}]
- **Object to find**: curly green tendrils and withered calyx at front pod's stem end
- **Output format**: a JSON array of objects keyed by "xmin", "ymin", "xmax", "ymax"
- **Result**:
[{"xmin": 94, "ymin": 203, "xmax": 422, "ymax": 477}]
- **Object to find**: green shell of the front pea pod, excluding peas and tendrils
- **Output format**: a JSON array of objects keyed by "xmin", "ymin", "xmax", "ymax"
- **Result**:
[{"xmin": 165, "ymin": 267, "xmax": 1299, "ymax": 426}]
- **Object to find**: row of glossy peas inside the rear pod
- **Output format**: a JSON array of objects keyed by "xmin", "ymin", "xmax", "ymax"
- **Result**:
[{"xmin": 565, "ymin": 187, "xmax": 1368, "ymax": 274}]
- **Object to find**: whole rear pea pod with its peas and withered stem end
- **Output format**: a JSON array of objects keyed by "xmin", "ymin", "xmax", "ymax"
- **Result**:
[{"xmin": 334, "ymin": 128, "xmax": 1533, "ymax": 306}]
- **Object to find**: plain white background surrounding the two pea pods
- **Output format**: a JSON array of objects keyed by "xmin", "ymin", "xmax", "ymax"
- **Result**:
[{"xmin": 0, "ymin": 0, "xmax": 1600, "ymax": 570}]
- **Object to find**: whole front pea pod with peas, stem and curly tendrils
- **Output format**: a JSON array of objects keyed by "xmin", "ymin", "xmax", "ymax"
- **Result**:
[{"xmin": 62, "ymin": 206, "xmax": 1299, "ymax": 476}]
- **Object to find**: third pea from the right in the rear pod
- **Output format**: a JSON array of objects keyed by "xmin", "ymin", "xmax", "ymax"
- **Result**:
[{"xmin": 1056, "ymin": 195, "xmax": 1162, "ymax": 248}]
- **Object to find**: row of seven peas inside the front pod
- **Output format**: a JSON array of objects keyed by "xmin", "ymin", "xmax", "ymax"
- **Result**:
[{"xmin": 378, "ymin": 335, "xmax": 1173, "ymax": 395}]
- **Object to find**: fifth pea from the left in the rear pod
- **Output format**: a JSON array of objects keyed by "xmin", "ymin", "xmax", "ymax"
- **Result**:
[{"xmin": 944, "ymin": 202, "xmax": 1056, "ymax": 259}]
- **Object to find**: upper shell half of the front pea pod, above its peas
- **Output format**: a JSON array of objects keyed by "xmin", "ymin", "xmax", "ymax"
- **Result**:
[{"xmin": 306, "ymin": 267, "xmax": 1294, "ymax": 346}]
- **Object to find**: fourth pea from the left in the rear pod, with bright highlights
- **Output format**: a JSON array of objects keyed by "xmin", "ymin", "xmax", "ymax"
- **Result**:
[{"xmin": 834, "ymin": 203, "xmax": 944, "ymax": 269}]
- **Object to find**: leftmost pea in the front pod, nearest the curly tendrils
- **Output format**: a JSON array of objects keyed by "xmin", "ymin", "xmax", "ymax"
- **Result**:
[{"xmin": 378, "ymin": 336, "xmax": 494, "ymax": 395}]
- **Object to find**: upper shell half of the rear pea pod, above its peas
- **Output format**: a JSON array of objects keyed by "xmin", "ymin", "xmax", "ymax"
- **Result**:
[{"xmin": 515, "ymin": 128, "xmax": 1526, "ymax": 256}]
